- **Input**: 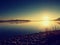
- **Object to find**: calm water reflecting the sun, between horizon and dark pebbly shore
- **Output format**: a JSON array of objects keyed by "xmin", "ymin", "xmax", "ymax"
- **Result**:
[{"xmin": 0, "ymin": 21, "xmax": 60, "ymax": 40}]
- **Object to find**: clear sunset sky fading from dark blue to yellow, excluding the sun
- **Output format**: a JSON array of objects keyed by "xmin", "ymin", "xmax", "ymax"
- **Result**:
[{"xmin": 0, "ymin": 0, "xmax": 60, "ymax": 20}]
